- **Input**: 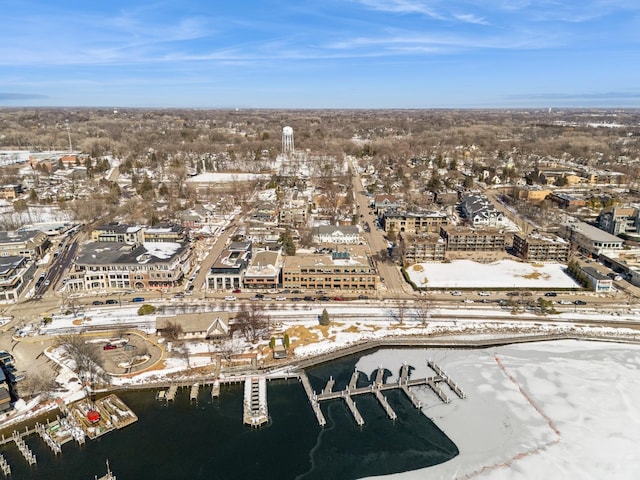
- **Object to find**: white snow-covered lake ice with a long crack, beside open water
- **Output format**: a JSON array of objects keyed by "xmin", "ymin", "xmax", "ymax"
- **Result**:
[{"xmin": 357, "ymin": 340, "xmax": 640, "ymax": 480}]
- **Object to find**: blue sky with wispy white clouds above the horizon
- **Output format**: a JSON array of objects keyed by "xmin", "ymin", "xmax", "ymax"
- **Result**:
[{"xmin": 0, "ymin": 0, "xmax": 640, "ymax": 108}]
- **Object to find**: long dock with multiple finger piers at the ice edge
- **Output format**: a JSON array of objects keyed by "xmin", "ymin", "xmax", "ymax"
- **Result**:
[{"xmin": 300, "ymin": 361, "xmax": 465, "ymax": 426}]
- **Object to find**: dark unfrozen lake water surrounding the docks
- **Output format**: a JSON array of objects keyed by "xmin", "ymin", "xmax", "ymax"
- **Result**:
[{"xmin": 0, "ymin": 357, "xmax": 458, "ymax": 480}]
